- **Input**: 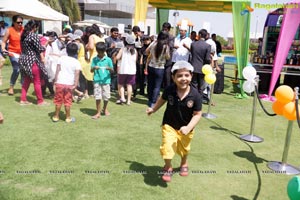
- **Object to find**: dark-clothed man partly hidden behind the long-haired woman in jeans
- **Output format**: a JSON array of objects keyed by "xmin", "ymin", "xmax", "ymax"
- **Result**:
[{"xmin": 162, "ymin": 22, "xmax": 175, "ymax": 87}]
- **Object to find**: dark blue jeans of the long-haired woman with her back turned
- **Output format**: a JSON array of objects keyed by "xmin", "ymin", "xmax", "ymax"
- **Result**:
[{"xmin": 147, "ymin": 66, "xmax": 165, "ymax": 107}]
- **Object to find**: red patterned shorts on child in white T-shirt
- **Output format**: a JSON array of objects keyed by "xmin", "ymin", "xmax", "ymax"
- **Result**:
[{"xmin": 53, "ymin": 84, "xmax": 73, "ymax": 106}]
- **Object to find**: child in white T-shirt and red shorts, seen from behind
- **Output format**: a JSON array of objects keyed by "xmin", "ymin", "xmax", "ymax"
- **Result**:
[{"xmin": 52, "ymin": 43, "xmax": 81, "ymax": 123}]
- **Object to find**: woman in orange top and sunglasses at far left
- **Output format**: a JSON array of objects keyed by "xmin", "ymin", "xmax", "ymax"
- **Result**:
[{"xmin": 1, "ymin": 15, "xmax": 23, "ymax": 95}]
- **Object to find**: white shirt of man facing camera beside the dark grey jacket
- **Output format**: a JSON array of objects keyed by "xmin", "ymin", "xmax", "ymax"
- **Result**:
[{"xmin": 172, "ymin": 37, "xmax": 192, "ymax": 62}]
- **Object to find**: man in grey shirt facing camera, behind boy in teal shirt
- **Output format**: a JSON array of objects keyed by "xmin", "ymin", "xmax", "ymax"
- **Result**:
[{"xmin": 105, "ymin": 27, "xmax": 122, "ymax": 91}]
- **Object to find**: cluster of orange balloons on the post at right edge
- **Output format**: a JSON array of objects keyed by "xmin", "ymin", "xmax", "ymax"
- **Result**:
[{"xmin": 272, "ymin": 85, "xmax": 300, "ymax": 120}]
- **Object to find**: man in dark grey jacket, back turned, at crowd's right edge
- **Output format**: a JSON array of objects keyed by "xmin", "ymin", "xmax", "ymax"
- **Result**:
[{"xmin": 190, "ymin": 29, "xmax": 211, "ymax": 95}]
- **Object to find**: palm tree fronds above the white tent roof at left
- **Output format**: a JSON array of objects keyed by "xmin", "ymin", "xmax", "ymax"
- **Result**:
[{"xmin": 39, "ymin": 0, "xmax": 81, "ymax": 24}]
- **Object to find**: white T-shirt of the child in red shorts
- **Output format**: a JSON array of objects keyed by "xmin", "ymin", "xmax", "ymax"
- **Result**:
[{"xmin": 56, "ymin": 56, "xmax": 81, "ymax": 85}]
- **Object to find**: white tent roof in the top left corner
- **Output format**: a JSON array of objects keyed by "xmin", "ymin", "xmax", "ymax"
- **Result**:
[{"xmin": 0, "ymin": 0, "xmax": 69, "ymax": 21}]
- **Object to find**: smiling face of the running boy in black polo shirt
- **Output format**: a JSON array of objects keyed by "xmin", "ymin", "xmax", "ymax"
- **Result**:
[{"xmin": 172, "ymin": 69, "xmax": 192, "ymax": 90}]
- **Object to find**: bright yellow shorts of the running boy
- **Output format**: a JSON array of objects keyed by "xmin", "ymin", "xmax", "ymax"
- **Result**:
[{"xmin": 160, "ymin": 124, "xmax": 194, "ymax": 159}]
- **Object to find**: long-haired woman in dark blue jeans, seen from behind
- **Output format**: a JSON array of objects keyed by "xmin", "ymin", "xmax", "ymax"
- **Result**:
[{"xmin": 146, "ymin": 32, "xmax": 170, "ymax": 108}]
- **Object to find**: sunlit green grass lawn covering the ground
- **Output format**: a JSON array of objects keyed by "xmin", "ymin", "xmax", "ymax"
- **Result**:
[{"xmin": 0, "ymin": 59, "xmax": 300, "ymax": 200}]
